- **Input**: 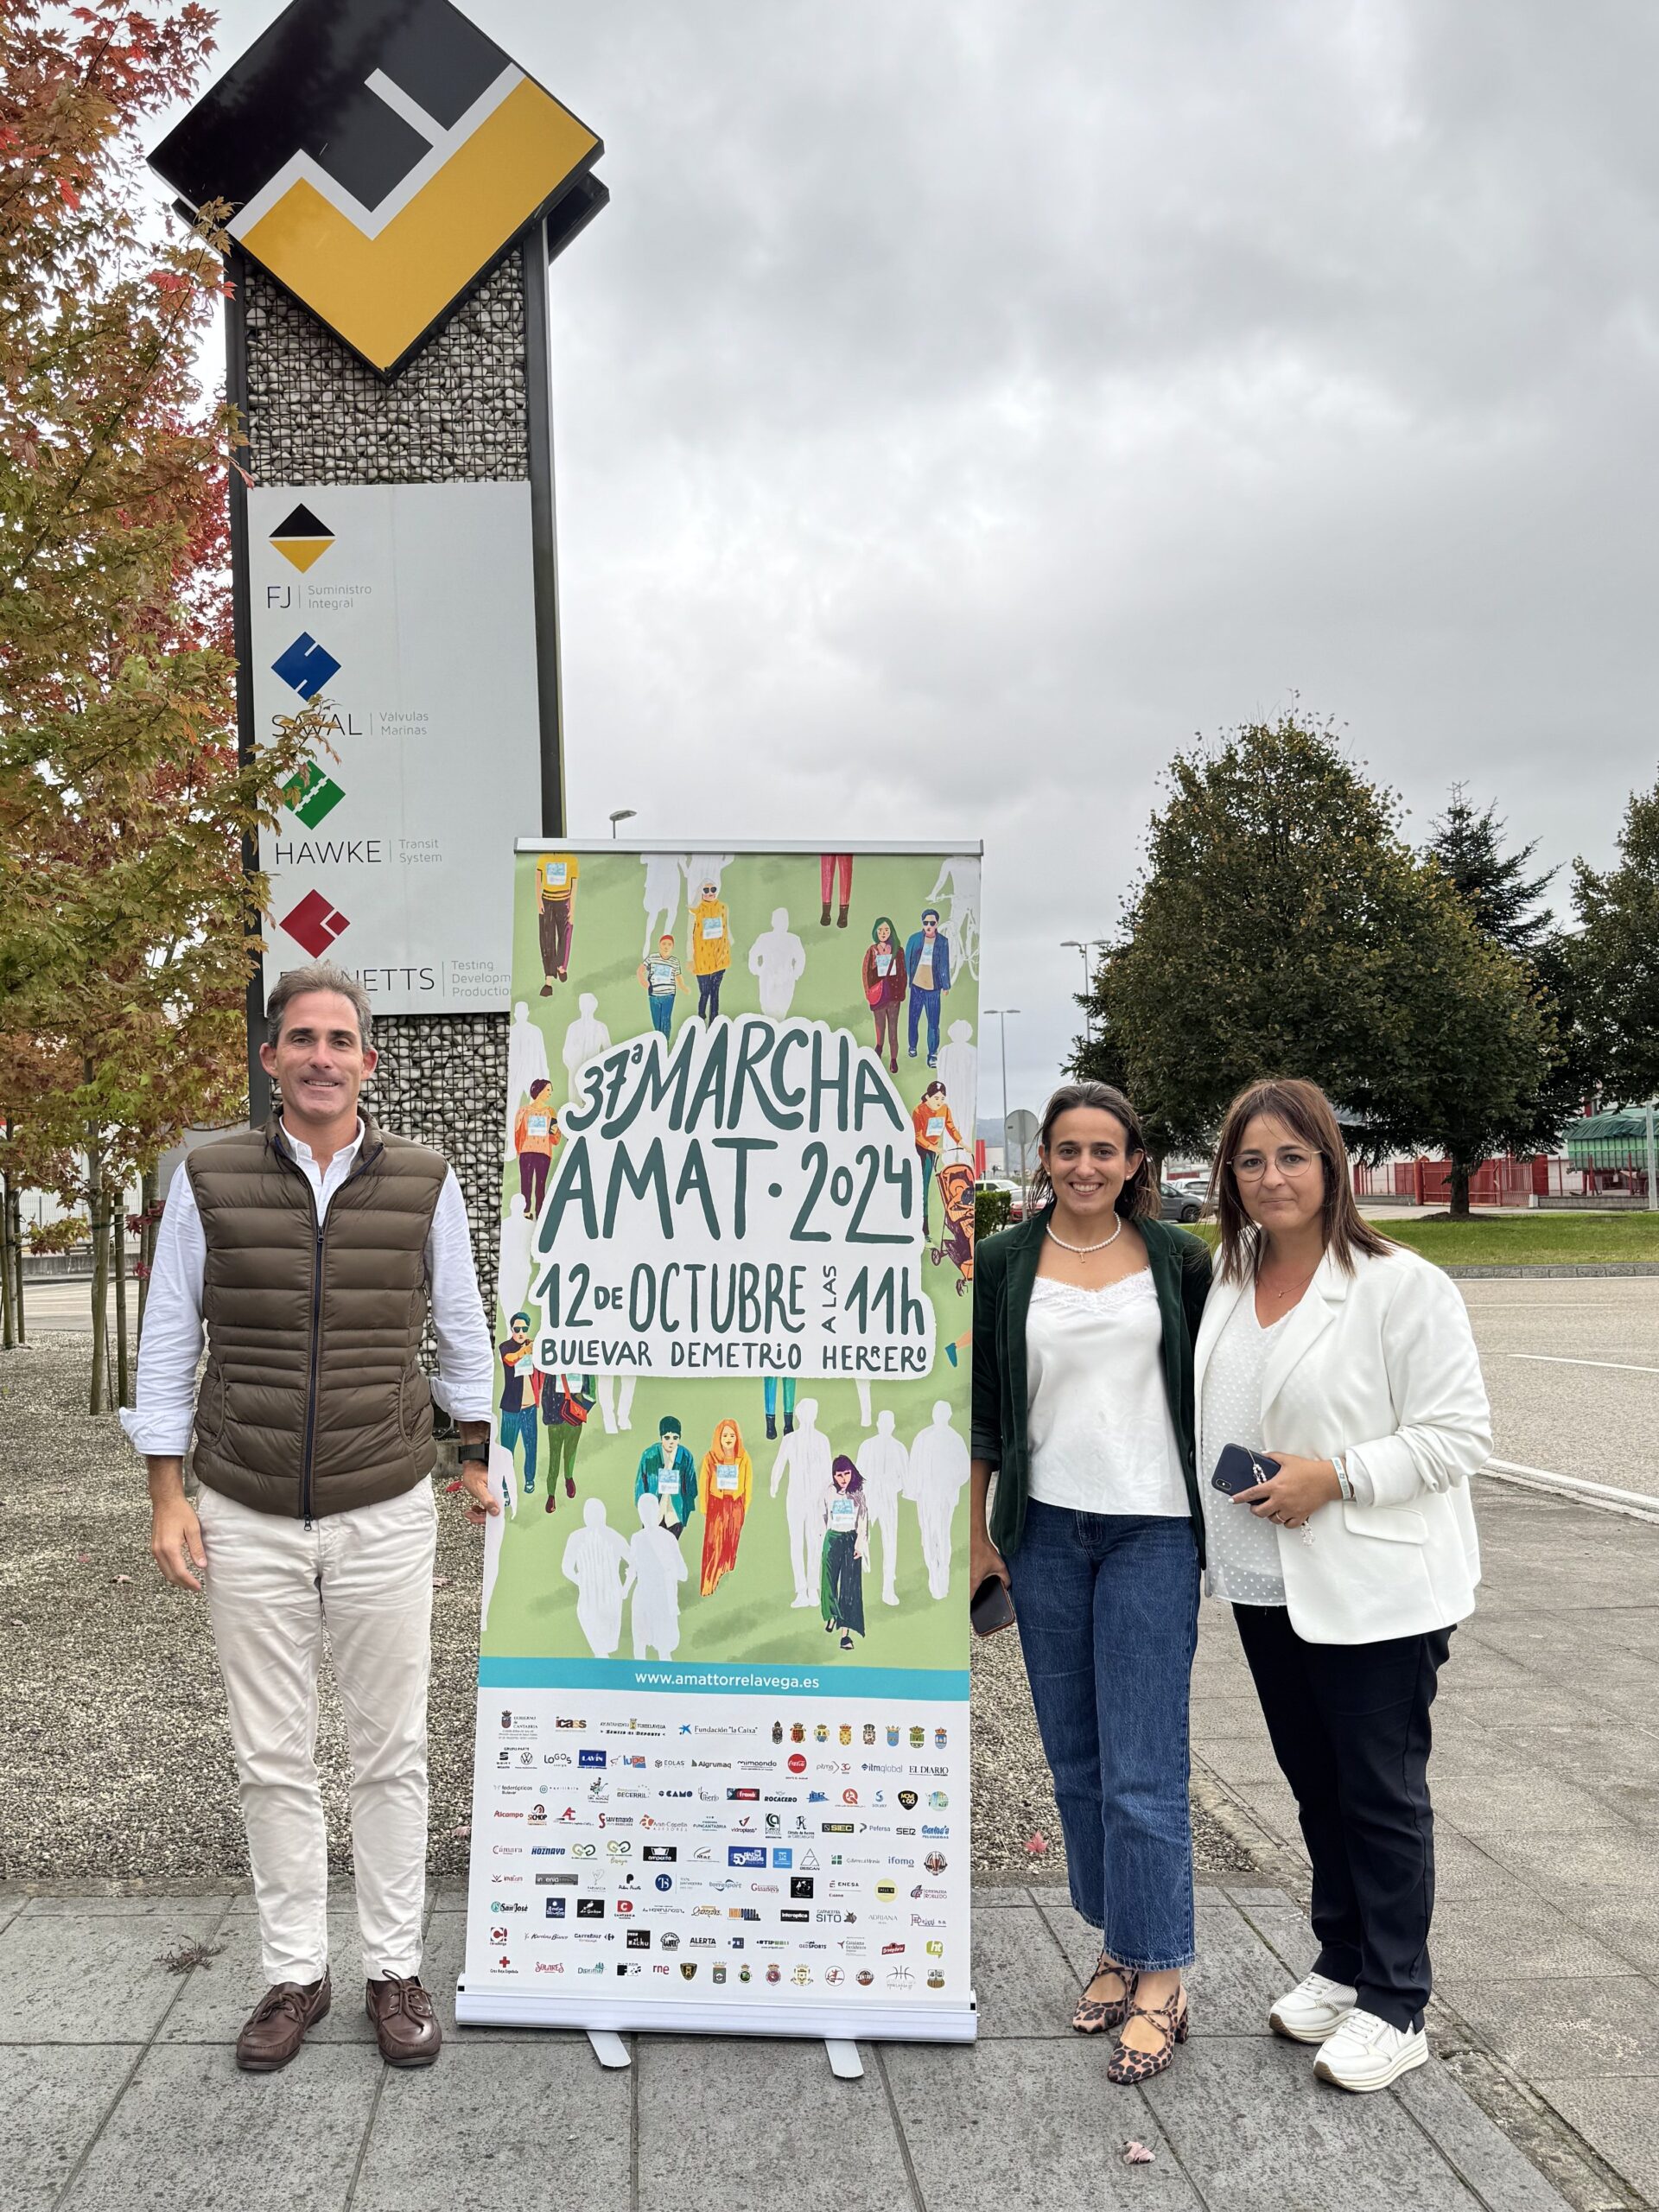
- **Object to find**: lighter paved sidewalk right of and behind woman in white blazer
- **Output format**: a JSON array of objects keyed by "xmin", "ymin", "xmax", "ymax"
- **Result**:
[{"xmin": 1192, "ymin": 1480, "xmax": 1659, "ymax": 2212}]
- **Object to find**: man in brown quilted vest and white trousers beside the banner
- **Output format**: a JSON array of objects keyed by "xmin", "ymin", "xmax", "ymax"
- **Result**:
[{"xmin": 122, "ymin": 963, "xmax": 500, "ymax": 2073}]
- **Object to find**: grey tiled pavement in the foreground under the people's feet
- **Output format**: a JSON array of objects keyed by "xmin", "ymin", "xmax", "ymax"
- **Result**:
[{"xmin": 0, "ymin": 1885, "xmax": 1561, "ymax": 2212}]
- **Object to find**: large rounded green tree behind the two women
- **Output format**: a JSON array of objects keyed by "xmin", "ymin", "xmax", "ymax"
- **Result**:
[{"xmin": 1075, "ymin": 715, "xmax": 1551, "ymax": 1221}]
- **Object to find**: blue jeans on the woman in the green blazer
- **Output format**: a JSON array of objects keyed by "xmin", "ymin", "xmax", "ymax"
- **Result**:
[{"xmin": 1008, "ymin": 1500, "xmax": 1199, "ymax": 1974}]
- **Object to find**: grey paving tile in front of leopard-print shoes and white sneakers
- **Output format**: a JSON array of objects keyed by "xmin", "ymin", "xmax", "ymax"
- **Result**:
[{"xmin": 1146, "ymin": 2035, "xmax": 1478, "ymax": 2212}]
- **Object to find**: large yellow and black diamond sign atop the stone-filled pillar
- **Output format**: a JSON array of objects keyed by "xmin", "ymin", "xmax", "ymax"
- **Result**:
[{"xmin": 150, "ymin": 0, "xmax": 606, "ymax": 376}]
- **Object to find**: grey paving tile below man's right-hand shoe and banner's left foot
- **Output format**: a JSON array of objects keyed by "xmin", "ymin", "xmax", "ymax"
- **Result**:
[{"xmin": 352, "ymin": 2039, "xmax": 632, "ymax": 2212}]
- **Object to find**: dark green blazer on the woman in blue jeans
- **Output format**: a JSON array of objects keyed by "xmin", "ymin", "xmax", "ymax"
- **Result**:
[{"xmin": 973, "ymin": 1208, "xmax": 1210, "ymax": 1561}]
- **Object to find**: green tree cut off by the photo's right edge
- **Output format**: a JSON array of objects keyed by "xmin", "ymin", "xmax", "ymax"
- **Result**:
[{"xmin": 1573, "ymin": 785, "xmax": 1659, "ymax": 1103}]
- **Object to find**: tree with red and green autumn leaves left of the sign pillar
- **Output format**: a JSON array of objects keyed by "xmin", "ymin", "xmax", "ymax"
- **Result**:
[{"xmin": 0, "ymin": 0, "xmax": 319, "ymax": 1411}]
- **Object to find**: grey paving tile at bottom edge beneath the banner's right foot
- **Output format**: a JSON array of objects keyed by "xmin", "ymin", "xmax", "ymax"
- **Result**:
[{"xmin": 641, "ymin": 2035, "xmax": 915, "ymax": 2212}]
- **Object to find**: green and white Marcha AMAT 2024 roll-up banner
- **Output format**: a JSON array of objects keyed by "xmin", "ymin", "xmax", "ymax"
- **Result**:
[{"xmin": 458, "ymin": 842, "xmax": 980, "ymax": 2039}]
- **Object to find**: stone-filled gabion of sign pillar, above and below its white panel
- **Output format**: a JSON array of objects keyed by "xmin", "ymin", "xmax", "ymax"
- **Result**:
[{"xmin": 244, "ymin": 257, "xmax": 529, "ymax": 1300}]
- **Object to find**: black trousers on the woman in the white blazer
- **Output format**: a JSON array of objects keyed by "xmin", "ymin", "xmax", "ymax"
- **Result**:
[{"xmin": 1232, "ymin": 1606, "xmax": 1451, "ymax": 2029}]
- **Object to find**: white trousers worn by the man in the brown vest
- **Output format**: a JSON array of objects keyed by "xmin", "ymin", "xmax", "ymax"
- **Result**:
[{"xmin": 197, "ymin": 1482, "xmax": 438, "ymax": 1982}]
